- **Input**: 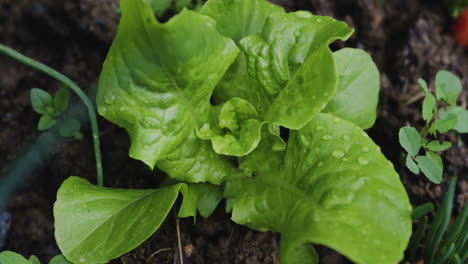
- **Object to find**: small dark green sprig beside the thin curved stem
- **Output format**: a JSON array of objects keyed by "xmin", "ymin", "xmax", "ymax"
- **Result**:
[{"xmin": 31, "ymin": 86, "xmax": 82, "ymax": 138}]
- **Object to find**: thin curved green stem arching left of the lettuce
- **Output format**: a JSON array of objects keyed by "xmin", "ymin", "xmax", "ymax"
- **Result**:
[{"xmin": 0, "ymin": 44, "xmax": 104, "ymax": 186}]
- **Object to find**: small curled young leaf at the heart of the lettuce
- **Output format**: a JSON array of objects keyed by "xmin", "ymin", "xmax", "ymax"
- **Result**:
[{"xmin": 197, "ymin": 98, "xmax": 264, "ymax": 157}]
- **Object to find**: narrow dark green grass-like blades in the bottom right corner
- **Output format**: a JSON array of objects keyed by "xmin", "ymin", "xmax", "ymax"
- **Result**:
[{"xmin": 406, "ymin": 177, "xmax": 468, "ymax": 264}]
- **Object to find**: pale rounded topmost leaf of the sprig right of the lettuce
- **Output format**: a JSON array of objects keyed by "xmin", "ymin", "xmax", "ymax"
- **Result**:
[{"xmin": 436, "ymin": 71, "xmax": 462, "ymax": 105}]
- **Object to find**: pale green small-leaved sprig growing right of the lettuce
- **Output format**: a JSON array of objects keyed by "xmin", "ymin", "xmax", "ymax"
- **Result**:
[{"xmin": 399, "ymin": 71, "xmax": 468, "ymax": 184}]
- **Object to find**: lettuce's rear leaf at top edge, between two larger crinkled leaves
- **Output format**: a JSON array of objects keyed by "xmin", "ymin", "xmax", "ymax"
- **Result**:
[{"xmin": 200, "ymin": 0, "xmax": 284, "ymax": 42}]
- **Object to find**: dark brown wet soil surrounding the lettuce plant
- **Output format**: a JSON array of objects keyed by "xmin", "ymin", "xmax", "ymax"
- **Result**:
[{"xmin": 0, "ymin": 0, "xmax": 468, "ymax": 264}]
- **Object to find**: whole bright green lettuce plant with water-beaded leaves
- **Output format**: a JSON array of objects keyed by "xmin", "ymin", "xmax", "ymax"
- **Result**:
[{"xmin": 0, "ymin": 0, "xmax": 411, "ymax": 264}]
